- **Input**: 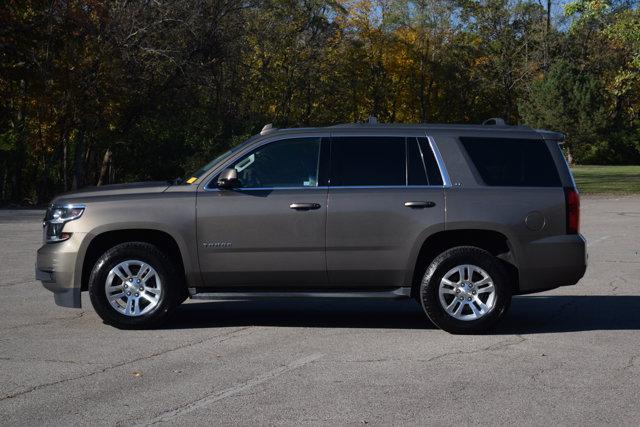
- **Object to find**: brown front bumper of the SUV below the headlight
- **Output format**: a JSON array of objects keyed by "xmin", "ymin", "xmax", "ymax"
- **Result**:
[{"xmin": 35, "ymin": 233, "xmax": 85, "ymax": 308}]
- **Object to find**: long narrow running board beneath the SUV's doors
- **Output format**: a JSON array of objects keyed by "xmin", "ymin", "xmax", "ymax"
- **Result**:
[{"xmin": 189, "ymin": 287, "xmax": 411, "ymax": 301}]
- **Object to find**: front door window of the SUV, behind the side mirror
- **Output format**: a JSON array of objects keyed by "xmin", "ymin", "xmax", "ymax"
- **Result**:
[{"xmin": 231, "ymin": 138, "xmax": 320, "ymax": 188}]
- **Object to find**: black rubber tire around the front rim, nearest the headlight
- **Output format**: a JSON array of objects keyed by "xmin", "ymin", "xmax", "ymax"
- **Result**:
[{"xmin": 88, "ymin": 242, "xmax": 186, "ymax": 329}]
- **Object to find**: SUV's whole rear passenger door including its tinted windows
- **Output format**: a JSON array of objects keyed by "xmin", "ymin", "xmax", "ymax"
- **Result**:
[{"xmin": 327, "ymin": 133, "xmax": 445, "ymax": 288}]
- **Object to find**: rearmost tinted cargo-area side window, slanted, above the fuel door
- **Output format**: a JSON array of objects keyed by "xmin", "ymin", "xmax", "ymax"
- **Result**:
[{"xmin": 460, "ymin": 138, "xmax": 561, "ymax": 187}]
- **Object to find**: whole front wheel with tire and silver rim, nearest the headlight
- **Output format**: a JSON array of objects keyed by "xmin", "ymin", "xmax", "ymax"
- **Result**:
[{"xmin": 89, "ymin": 242, "xmax": 184, "ymax": 328}]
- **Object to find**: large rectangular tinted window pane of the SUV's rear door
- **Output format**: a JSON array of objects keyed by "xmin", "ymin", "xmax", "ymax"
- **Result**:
[{"xmin": 331, "ymin": 137, "xmax": 407, "ymax": 186}]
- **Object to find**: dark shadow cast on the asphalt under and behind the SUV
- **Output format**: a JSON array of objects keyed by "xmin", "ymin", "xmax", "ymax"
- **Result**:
[{"xmin": 163, "ymin": 295, "xmax": 640, "ymax": 335}]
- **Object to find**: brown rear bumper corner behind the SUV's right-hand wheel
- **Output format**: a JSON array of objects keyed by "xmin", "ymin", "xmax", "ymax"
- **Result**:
[{"xmin": 519, "ymin": 234, "xmax": 587, "ymax": 294}]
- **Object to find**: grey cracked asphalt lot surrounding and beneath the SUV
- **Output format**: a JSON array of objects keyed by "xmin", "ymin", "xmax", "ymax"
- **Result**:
[{"xmin": 0, "ymin": 197, "xmax": 640, "ymax": 425}]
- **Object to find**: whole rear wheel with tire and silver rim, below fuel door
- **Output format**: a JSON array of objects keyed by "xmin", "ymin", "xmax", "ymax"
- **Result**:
[{"xmin": 420, "ymin": 246, "xmax": 511, "ymax": 334}]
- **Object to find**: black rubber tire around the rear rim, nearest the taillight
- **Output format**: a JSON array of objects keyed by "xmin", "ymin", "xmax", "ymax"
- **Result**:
[{"xmin": 420, "ymin": 246, "xmax": 511, "ymax": 334}]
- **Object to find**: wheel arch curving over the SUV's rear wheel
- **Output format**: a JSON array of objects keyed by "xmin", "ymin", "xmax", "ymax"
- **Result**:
[{"xmin": 407, "ymin": 228, "xmax": 519, "ymax": 297}]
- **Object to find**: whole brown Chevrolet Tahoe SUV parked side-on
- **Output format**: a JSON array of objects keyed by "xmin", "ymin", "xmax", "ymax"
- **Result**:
[{"xmin": 36, "ymin": 122, "xmax": 586, "ymax": 333}]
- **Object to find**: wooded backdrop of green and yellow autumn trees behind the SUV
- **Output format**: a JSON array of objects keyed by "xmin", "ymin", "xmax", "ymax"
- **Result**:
[{"xmin": 0, "ymin": 0, "xmax": 640, "ymax": 204}]
